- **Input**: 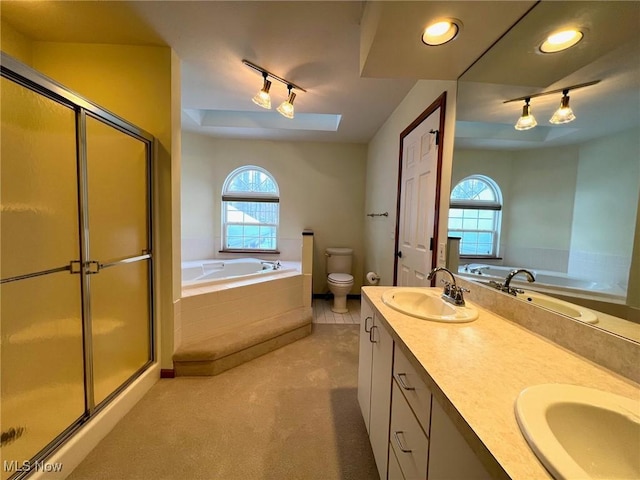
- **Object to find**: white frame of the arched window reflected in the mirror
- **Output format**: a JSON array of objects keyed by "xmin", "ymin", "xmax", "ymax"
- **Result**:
[{"xmin": 448, "ymin": 175, "xmax": 503, "ymax": 258}]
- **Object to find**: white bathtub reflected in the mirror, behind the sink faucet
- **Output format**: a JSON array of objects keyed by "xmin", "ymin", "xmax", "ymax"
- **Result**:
[{"xmin": 458, "ymin": 263, "xmax": 626, "ymax": 299}]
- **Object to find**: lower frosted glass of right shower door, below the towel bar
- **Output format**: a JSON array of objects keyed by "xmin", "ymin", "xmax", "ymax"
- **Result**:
[{"xmin": 91, "ymin": 260, "xmax": 151, "ymax": 405}]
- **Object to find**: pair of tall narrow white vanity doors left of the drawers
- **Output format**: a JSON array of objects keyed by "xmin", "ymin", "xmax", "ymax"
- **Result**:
[{"xmin": 358, "ymin": 297, "xmax": 393, "ymax": 479}]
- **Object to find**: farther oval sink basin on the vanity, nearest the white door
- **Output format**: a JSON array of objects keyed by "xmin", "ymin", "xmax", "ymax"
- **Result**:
[{"xmin": 382, "ymin": 287, "xmax": 478, "ymax": 323}]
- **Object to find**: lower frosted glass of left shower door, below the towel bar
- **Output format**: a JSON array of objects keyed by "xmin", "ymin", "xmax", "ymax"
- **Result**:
[{"xmin": 0, "ymin": 272, "xmax": 85, "ymax": 479}]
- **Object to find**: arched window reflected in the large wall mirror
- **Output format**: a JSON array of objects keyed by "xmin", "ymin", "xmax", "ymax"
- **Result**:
[{"xmin": 449, "ymin": 175, "xmax": 502, "ymax": 257}]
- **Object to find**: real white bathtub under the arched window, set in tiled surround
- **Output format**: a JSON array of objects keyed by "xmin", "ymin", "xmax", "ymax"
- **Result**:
[{"xmin": 182, "ymin": 258, "xmax": 291, "ymax": 287}]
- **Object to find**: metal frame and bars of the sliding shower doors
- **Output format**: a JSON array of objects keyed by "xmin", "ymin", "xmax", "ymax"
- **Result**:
[{"xmin": 0, "ymin": 51, "xmax": 157, "ymax": 480}]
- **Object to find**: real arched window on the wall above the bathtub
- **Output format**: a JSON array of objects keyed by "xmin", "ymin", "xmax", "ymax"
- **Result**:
[{"xmin": 222, "ymin": 165, "xmax": 280, "ymax": 251}]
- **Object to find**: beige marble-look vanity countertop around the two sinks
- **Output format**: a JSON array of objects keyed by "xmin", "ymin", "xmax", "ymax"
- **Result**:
[{"xmin": 362, "ymin": 287, "xmax": 640, "ymax": 480}]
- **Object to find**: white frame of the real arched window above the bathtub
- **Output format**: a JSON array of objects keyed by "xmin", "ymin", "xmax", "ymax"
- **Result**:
[{"xmin": 221, "ymin": 165, "xmax": 280, "ymax": 253}]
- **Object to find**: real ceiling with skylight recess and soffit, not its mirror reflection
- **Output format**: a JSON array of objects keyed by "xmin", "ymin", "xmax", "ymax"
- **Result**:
[{"xmin": 0, "ymin": 0, "xmax": 534, "ymax": 143}]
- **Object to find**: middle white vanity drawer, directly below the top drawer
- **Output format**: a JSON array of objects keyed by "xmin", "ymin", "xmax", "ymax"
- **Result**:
[{"xmin": 389, "ymin": 380, "xmax": 429, "ymax": 480}]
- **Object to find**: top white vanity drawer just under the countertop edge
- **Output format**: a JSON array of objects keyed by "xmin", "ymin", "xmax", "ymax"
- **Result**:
[{"xmin": 393, "ymin": 345, "xmax": 431, "ymax": 433}]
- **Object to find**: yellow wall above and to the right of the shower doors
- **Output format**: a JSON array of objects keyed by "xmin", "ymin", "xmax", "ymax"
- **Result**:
[{"xmin": 1, "ymin": 22, "xmax": 180, "ymax": 368}]
